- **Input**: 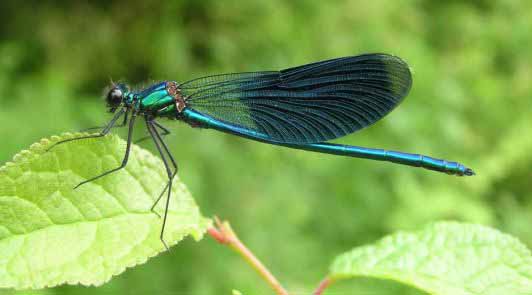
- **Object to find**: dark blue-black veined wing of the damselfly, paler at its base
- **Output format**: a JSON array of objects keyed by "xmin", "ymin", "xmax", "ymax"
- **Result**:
[{"xmin": 179, "ymin": 54, "xmax": 412, "ymax": 143}]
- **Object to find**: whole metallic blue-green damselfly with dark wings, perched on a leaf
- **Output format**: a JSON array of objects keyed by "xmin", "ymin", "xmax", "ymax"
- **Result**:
[{"xmin": 47, "ymin": 54, "xmax": 474, "ymax": 250}]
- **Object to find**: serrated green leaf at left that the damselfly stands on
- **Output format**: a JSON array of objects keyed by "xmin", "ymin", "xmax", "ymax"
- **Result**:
[{"xmin": 0, "ymin": 134, "xmax": 209, "ymax": 289}]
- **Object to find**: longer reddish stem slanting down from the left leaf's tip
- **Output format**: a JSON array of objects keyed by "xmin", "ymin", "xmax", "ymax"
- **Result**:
[{"xmin": 208, "ymin": 217, "xmax": 288, "ymax": 295}]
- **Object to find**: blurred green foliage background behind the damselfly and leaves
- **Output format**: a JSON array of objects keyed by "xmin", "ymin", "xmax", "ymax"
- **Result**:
[{"xmin": 0, "ymin": 0, "xmax": 532, "ymax": 295}]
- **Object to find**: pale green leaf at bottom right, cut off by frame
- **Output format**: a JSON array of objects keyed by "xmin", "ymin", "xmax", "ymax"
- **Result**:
[{"xmin": 330, "ymin": 222, "xmax": 532, "ymax": 295}]
